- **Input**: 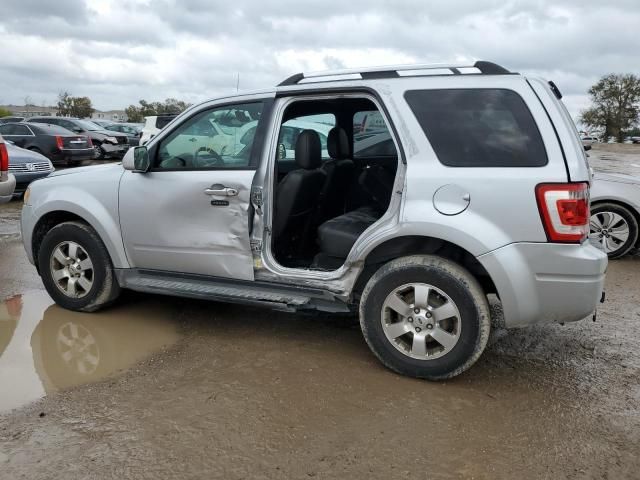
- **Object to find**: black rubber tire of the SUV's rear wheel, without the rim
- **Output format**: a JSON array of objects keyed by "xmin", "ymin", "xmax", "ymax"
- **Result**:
[{"xmin": 360, "ymin": 255, "xmax": 491, "ymax": 380}]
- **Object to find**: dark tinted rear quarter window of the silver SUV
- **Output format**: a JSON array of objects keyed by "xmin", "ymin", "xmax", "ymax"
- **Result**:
[{"xmin": 405, "ymin": 89, "xmax": 547, "ymax": 167}]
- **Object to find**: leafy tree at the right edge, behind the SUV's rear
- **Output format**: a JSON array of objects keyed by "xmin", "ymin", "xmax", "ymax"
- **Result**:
[{"xmin": 580, "ymin": 73, "xmax": 640, "ymax": 142}]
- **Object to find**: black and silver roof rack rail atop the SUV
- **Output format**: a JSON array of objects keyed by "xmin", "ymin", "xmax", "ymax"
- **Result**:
[{"xmin": 278, "ymin": 60, "xmax": 515, "ymax": 87}]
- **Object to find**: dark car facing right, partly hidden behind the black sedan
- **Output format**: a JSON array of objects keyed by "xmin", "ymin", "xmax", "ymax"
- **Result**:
[{"xmin": 27, "ymin": 117, "xmax": 129, "ymax": 159}]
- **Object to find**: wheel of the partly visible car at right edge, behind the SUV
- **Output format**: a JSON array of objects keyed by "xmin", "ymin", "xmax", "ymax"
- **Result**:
[{"xmin": 589, "ymin": 202, "xmax": 638, "ymax": 258}]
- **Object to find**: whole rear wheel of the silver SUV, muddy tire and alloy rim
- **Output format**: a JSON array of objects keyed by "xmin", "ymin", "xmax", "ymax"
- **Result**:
[{"xmin": 360, "ymin": 255, "xmax": 490, "ymax": 380}]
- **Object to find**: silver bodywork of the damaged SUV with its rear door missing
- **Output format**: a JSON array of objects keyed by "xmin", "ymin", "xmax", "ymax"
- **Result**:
[{"xmin": 23, "ymin": 68, "xmax": 606, "ymax": 326}]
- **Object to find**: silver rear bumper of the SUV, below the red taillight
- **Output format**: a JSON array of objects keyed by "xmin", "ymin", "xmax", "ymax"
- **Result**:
[{"xmin": 478, "ymin": 242, "xmax": 607, "ymax": 327}]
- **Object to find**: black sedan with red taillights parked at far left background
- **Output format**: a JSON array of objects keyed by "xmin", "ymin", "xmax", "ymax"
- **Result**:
[{"xmin": 0, "ymin": 123, "xmax": 94, "ymax": 167}]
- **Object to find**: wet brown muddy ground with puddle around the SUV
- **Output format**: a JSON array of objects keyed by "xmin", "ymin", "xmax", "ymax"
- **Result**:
[{"xmin": 0, "ymin": 151, "xmax": 640, "ymax": 479}]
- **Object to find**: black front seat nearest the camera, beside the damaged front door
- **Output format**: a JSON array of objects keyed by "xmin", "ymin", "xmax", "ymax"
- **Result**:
[{"xmin": 273, "ymin": 130, "xmax": 326, "ymax": 255}]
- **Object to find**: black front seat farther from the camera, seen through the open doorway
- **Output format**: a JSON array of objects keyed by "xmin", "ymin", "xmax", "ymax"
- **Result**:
[{"xmin": 317, "ymin": 127, "xmax": 355, "ymax": 224}]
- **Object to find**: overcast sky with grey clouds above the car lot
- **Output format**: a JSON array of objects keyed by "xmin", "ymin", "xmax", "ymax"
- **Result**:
[{"xmin": 0, "ymin": 0, "xmax": 640, "ymax": 117}]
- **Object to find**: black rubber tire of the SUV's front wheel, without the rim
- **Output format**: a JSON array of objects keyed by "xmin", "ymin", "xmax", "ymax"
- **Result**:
[{"xmin": 38, "ymin": 222, "xmax": 120, "ymax": 312}]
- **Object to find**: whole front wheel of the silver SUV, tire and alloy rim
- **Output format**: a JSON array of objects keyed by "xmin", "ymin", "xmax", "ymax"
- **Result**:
[{"xmin": 37, "ymin": 222, "xmax": 120, "ymax": 312}]
